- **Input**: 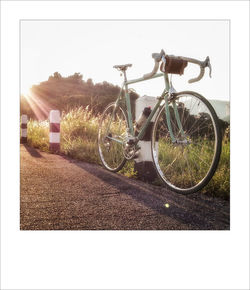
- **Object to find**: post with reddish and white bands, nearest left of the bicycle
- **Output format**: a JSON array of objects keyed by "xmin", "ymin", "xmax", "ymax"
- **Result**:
[{"xmin": 49, "ymin": 110, "xmax": 61, "ymax": 153}]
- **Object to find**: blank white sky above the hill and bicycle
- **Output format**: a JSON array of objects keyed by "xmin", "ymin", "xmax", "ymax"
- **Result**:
[{"xmin": 20, "ymin": 20, "xmax": 230, "ymax": 100}]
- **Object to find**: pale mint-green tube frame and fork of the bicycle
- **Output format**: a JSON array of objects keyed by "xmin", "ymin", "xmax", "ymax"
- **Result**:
[{"xmin": 113, "ymin": 71, "xmax": 185, "ymax": 142}]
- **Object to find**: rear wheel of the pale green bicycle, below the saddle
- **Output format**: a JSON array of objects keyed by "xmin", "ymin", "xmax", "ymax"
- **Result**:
[{"xmin": 98, "ymin": 103, "xmax": 128, "ymax": 172}]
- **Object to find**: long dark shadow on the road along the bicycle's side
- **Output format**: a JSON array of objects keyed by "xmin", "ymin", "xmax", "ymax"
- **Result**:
[{"xmin": 63, "ymin": 156, "xmax": 230, "ymax": 230}]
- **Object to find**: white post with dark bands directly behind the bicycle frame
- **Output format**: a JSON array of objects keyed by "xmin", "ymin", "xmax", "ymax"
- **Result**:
[{"xmin": 134, "ymin": 96, "xmax": 157, "ymax": 181}]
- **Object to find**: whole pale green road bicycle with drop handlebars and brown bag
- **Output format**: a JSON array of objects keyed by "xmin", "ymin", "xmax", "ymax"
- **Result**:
[{"xmin": 98, "ymin": 50, "xmax": 222, "ymax": 194}]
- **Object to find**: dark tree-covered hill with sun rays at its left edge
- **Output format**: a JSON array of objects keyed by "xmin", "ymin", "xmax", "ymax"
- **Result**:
[{"xmin": 20, "ymin": 72, "xmax": 138, "ymax": 120}]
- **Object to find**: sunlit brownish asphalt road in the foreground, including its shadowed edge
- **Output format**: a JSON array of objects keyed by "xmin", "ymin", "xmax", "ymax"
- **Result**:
[{"xmin": 20, "ymin": 145, "xmax": 230, "ymax": 230}]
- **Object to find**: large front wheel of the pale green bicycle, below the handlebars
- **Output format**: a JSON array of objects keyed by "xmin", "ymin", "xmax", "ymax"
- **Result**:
[{"xmin": 151, "ymin": 91, "xmax": 222, "ymax": 194}]
